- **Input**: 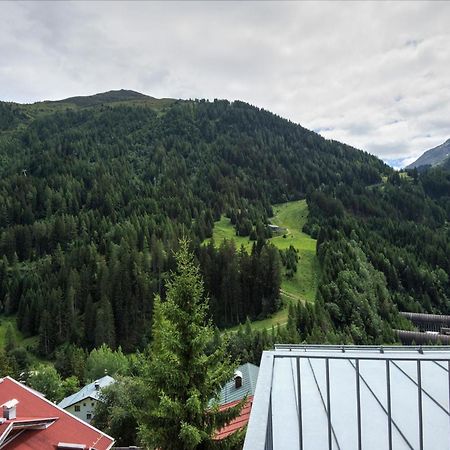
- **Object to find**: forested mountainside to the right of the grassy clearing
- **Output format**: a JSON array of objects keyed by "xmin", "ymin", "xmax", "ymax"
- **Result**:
[{"xmin": 302, "ymin": 165, "xmax": 450, "ymax": 342}]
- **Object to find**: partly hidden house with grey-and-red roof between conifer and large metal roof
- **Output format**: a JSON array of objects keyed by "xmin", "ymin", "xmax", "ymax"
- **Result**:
[{"xmin": 216, "ymin": 363, "xmax": 259, "ymax": 439}]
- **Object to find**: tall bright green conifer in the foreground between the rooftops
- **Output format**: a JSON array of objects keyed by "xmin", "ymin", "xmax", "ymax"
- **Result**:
[{"xmin": 140, "ymin": 240, "xmax": 243, "ymax": 450}]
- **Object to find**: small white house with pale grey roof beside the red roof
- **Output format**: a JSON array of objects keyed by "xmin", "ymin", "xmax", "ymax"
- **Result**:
[{"xmin": 58, "ymin": 375, "xmax": 115, "ymax": 423}]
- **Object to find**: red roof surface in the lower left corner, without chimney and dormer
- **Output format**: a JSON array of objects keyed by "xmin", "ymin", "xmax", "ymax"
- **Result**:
[{"xmin": 0, "ymin": 377, "xmax": 114, "ymax": 450}]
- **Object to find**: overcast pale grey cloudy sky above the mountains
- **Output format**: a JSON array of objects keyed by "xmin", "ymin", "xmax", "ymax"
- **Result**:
[{"xmin": 0, "ymin": 1, "xmax": 450, "ymax": 166}]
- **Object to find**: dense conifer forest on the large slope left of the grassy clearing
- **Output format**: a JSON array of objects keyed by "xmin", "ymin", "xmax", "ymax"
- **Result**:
[{"xmin": 0, "ymin": 94, "xmax": 388, "ymax": 355}]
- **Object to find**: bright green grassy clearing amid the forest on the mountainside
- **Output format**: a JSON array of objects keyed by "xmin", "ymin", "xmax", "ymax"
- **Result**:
[{"xmin": 207, "ymin": 200, "xmax": 320, "ymax": 330}]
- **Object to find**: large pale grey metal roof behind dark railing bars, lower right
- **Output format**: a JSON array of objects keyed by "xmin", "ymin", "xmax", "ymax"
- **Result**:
[{"xmin": 244, "ymin": 346, "xmax": 450, "ymax": 450}]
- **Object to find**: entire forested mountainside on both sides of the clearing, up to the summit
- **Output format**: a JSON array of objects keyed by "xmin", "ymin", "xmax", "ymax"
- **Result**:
[{"xmin": 0, "ymin": 91, "xmax": 450, "ymax": 355}]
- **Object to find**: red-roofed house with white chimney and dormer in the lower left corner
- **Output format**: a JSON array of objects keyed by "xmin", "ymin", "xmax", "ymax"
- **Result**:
[{"xmin": 0, "ymin": 377, "xmax": 114, "ymax": 450}]
